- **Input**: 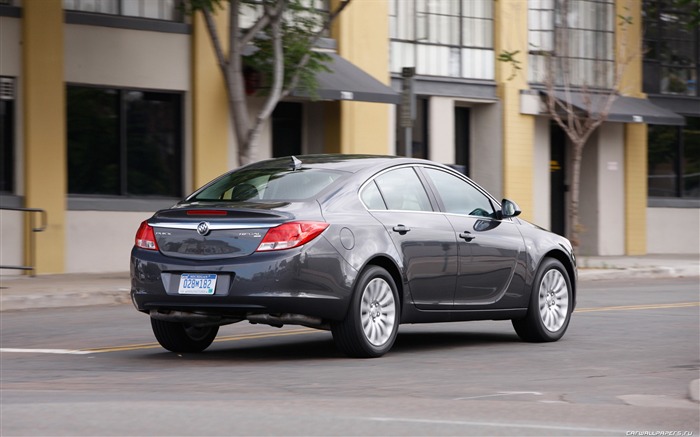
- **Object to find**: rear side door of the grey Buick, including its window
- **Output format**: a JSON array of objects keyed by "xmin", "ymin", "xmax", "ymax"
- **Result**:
[{"xmin": 360, "ymin": 167, "xmax": 458, "ymax": 310}]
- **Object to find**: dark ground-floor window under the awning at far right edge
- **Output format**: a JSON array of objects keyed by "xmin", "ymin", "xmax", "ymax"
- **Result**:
[{"xmin": 648, "ymin": 117, "xmax": 700, "ymax": 199}]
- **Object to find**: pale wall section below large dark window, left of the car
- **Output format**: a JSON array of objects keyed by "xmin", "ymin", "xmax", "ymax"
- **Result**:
[{"xmin": 66, "ymin": 211, "xmax": 152, "ymax": 273}]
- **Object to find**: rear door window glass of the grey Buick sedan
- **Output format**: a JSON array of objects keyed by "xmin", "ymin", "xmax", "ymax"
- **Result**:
[{"xmin": 375, "ymin": 167, "xmax": 433, "ymax": 211}]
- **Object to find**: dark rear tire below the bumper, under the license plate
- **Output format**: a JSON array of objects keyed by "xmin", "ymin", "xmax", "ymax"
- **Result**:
[{"xmin": 151, "ymin": 318, "xmax": 219, "ymax": 352}]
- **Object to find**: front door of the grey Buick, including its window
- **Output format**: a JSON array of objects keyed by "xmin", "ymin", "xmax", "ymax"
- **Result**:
[{"xmin": 421, "ymin": 167, "xmax": 524, "ymax": 310}]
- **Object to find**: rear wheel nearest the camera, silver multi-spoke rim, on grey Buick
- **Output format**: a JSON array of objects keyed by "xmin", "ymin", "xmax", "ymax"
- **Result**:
[{"xmin": 331, "ymin": 266, "xmax": 400, "ymax": 358}]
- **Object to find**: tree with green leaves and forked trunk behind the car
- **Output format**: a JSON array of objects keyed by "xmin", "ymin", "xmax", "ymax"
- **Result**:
[{"xmin": 189, "ymin": 0, "xmax": 352, "ymax": 165}]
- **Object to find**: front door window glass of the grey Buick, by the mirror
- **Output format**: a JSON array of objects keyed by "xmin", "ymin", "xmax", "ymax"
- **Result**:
[{"xmin": 425, "ymin": 168, "xmax": 495, "ymax": 217}]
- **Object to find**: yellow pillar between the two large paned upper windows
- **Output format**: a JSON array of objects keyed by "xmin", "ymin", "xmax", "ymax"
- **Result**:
[{"xmin": 494, "ymin": 0, "xmax": 535, "ymax": 220}]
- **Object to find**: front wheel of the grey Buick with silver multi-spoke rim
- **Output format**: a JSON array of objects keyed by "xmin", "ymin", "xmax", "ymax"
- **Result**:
[{"xmin": 512, "ymin": 258, "xmax": 573, "ymax": 343}]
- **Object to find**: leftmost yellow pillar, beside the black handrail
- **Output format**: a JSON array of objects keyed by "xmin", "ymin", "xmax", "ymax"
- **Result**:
[{"xmin": 22, "ymin": 0, "xmax": 67, "ymax": 274}]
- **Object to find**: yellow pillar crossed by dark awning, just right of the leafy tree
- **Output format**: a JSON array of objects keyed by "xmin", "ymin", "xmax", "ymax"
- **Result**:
[{"xmin": 325, "ymin": 0, "xmax": 391, "ymax": 154}]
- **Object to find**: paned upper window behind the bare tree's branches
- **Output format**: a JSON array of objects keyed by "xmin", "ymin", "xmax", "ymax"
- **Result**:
[{"xmin": 528, "ymin": 0, "xmax": 616, "ymax": 89}]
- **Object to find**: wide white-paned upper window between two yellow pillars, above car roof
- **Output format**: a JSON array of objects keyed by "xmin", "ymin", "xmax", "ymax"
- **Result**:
[{"xmin": 389, "ymin": 0, "xmax": 495, "ymax": 80}]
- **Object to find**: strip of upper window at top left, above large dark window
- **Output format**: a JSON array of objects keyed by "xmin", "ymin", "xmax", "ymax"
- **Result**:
[{"xmin": 63, "ymin": 0, "xmax": 183, "ymax": 21}]
